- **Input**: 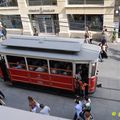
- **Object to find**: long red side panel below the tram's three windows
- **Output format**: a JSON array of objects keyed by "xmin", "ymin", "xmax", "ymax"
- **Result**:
[{"xmin": 9, "ymin": 68, "xmax": 74, "ymax": 91}]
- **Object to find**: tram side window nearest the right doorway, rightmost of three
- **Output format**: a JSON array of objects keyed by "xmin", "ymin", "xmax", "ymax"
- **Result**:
[{"xmin": 50, "ymin": 60, "xmax": 73, "ymax": 76}]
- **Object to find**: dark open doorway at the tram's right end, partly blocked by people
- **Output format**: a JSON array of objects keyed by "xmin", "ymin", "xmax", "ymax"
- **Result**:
[{"xmin": 76, "ymin": 63, "xmax": 89, "ymax": 95}]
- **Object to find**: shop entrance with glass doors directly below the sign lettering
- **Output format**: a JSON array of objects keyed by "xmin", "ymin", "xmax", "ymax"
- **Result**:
[{"xmin": 29, "ymin": 14, "xmax": 59, "ymax": 34}]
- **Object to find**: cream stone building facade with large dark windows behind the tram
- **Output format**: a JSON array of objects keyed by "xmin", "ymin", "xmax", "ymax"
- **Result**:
[{"xmin": 0, "ymin": 0, "xmax": 115, "ymax": 37}]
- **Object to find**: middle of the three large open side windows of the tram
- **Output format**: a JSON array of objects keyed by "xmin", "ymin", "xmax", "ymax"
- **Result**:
[{"xmin": 27, "ymin": 58, "xmax": 48, "ymax": 72}]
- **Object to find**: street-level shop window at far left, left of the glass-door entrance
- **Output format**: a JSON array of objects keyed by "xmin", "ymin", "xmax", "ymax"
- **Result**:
[{"xmin": 0, "ymin": 15, "xmax": 22, "ymax": 29}]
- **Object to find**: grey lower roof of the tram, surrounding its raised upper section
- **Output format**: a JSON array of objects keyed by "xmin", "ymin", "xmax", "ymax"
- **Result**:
[{"xmin": 0, "ymin": 35, "xmax": 100, "ymax": 61}]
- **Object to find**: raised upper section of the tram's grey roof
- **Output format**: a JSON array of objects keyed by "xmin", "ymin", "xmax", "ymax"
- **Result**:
[{"xmin": 2, "ymin": 36, "xmax": 83, "ymax": 52}]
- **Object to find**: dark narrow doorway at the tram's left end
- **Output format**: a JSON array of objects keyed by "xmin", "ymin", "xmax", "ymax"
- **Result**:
[{"xmin": 0, "ymin": 56, "xmax": 10, "ymax": 82}]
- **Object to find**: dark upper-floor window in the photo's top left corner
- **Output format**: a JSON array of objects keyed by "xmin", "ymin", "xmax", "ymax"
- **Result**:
[{"xmin": 0, "ymin": 0, "xmax": 18, "ymax": 7}]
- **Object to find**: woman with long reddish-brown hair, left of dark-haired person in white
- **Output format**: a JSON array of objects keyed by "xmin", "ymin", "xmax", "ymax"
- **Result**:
[{"xmin": 28, "ymin": 96, "xmax": 40, "ymax": 113}]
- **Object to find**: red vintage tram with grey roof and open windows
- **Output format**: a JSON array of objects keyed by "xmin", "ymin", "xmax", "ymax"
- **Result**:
[{"xmin": 0, "ymin": 36, "xmax": 100, "ymax": 93}]
